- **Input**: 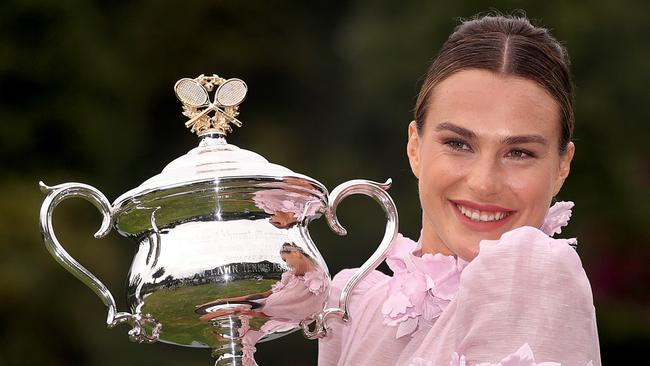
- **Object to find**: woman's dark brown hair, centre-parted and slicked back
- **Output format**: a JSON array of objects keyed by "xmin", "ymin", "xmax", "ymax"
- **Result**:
[{"xmin": 415, "ymin": 15, "xmax": 574, "ymax": 153}]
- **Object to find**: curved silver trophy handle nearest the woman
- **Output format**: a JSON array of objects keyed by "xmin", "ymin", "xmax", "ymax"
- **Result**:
[{"xmin": 301, "ymin": 179, "xmax": 398, "ymax": 339}]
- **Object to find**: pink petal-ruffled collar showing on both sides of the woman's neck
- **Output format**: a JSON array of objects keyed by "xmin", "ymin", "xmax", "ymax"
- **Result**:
[{"xmin": 381, "ymin": 202, "xmax": 574, "ymax": 338}]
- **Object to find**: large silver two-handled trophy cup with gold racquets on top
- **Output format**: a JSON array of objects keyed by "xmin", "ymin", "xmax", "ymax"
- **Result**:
[{"xmin": 40, "ymin": 75, "xmax": 398, "ymax": 366}]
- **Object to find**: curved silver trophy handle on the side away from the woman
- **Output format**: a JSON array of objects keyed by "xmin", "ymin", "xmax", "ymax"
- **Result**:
[{"xmin": 39, "ymin": 182, "xmax": 161, "ymax": 343}]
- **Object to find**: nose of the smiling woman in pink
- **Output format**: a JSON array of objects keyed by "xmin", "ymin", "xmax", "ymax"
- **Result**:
[{"xmin": 467, "ymin": 156, "xmax": 506, "ymax": 198}]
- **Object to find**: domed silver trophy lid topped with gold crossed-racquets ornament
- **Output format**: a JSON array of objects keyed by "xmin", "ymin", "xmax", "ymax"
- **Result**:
[{"xmin": 113, "ymin": 75, "xmax": 327, "ymax": 234}]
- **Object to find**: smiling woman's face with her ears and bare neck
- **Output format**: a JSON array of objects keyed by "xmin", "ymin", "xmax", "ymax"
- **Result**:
[{"xmin": 407, "ymin": 69, "xmax": 574, "ymax": 260}]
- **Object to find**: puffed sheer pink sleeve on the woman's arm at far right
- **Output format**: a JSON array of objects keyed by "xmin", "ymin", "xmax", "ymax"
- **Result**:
[{"xmin": 444, "ymin": 227, "xmax": 600, "ymax": 366}]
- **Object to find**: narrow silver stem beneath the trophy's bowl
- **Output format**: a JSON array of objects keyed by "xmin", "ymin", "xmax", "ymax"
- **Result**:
[{"xmin": 212, "ymin": 316, "xmax": 258, "ymax": 366}]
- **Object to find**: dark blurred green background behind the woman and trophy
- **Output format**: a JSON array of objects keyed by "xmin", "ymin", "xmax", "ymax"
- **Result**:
[{"xmin": 0, "ymin": 0, "xmax": 650, "ymax": 366}]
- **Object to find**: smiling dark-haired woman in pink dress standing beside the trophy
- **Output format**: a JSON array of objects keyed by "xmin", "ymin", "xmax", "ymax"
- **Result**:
[{"xmin": 319, "ymin": 12, "xmax": 600, "ymax": 366}]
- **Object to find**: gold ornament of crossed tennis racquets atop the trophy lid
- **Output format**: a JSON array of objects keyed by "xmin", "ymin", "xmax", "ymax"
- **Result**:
[{"xmin": 174, "ymin": 74, "xmax": 248, "ymax": 136}]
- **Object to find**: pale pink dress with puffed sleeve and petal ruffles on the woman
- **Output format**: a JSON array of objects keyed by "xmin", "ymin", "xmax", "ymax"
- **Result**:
[{"xmin": 318, "ymin": 202, "xmax": 601, "ymax": 366}]
